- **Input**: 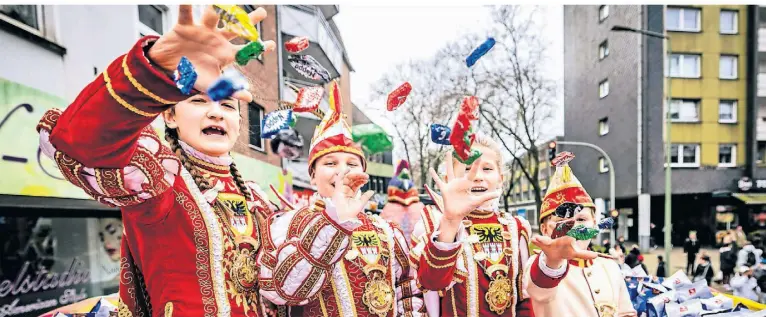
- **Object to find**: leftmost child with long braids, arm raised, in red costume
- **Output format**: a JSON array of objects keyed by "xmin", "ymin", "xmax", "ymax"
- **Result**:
[{"xmin": 38, "ymin": 5, "xmax": 282, "ymax": 316}]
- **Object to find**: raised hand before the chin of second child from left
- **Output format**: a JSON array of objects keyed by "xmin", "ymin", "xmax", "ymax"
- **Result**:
[{"xmin": 332, "ymin": 168, "xmax": 375, "ymax": 221}]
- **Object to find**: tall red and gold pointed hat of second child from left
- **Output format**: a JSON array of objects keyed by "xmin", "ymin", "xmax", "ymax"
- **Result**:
[{"xmin": 308, "ymin": 80, "xmax": 367, "ymax": 175}]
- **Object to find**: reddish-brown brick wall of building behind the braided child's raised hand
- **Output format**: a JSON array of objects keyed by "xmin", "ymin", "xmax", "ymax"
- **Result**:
[{"xmin": 234, "ymin": 5, "xmax": 282, "ymax": 166}]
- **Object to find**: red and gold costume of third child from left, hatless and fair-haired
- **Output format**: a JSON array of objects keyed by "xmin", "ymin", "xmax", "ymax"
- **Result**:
[{"xmin": 410, "ymin": 187, "xmax": 534, "ymax": 317}]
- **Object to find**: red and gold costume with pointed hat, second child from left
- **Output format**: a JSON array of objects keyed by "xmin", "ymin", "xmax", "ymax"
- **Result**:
[{"xmin": 260, "ymin": 82, "xmax": 422, "ymax": 317}]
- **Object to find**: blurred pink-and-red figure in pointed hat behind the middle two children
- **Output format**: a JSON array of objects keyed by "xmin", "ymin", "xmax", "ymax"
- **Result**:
[{"xmin": 380, "ymin": 160, "xmax": 424, "ymax": 245}]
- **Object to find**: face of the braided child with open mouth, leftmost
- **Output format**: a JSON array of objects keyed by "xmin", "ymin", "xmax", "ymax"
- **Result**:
[{"xmin": 163, "ymin": 94, "xmax": 241, "ymax": 156}]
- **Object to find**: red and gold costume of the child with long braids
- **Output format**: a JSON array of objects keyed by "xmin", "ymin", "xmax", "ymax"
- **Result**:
[{"xmin": 38, "ymin": 36, "xmax": 270, "ymax": 317}]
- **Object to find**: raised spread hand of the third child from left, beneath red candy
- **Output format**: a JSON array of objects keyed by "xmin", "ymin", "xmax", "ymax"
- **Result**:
[{"xmin": 430, "ymin": 154, "xmax": 500, "ymax": 222}]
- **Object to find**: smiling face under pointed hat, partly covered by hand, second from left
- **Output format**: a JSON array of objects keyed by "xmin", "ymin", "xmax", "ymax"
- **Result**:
[{"xmin": 311, "ymin": 152, "xmax": 364, "ymax": 197}]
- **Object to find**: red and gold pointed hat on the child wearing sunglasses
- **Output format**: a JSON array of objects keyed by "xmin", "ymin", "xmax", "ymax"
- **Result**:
[{"xmin": 540, "ymin": 152, "xmax": 595, "ymax": 221}]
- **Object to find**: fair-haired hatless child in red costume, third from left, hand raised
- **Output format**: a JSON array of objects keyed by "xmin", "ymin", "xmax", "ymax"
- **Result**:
[{"xmin": 411, "ymin": 134, "xmax": 534, "ymax": 317}]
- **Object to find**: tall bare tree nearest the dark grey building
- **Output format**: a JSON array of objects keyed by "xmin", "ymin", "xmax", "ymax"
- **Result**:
[{"xmin": 437, "ymin": 6, "xmax": 555, "ymax": 211}]
